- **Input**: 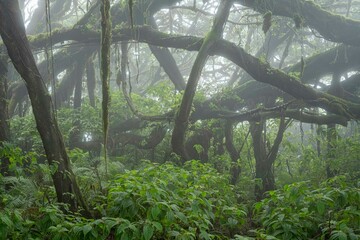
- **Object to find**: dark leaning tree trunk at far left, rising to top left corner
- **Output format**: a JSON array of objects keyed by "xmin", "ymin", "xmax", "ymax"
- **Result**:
[{"xmin": 0, "ymin": 0, "xmax": 87, "ymax": 214}]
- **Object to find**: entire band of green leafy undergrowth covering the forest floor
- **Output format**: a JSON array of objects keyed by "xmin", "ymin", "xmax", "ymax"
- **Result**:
[{"xmin": 0, "ymin": 149, "xmax": 360, "ymax": 240}]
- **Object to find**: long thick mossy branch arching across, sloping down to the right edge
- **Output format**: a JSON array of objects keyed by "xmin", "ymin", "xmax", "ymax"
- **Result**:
[{"xmin": 25, "ymin": 27, "xmax": 360, "ymax": 119}]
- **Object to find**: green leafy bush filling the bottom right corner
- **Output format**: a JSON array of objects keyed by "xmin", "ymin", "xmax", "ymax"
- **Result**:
[{"xmin": 254, "ymin": 177, "xmax": 360, "ymax": 239}]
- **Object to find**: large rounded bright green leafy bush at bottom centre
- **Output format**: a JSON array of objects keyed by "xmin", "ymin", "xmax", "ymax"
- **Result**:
[{"xmin": 108, "ymin": 161, "xmax": 246, "ymax": 239}]
